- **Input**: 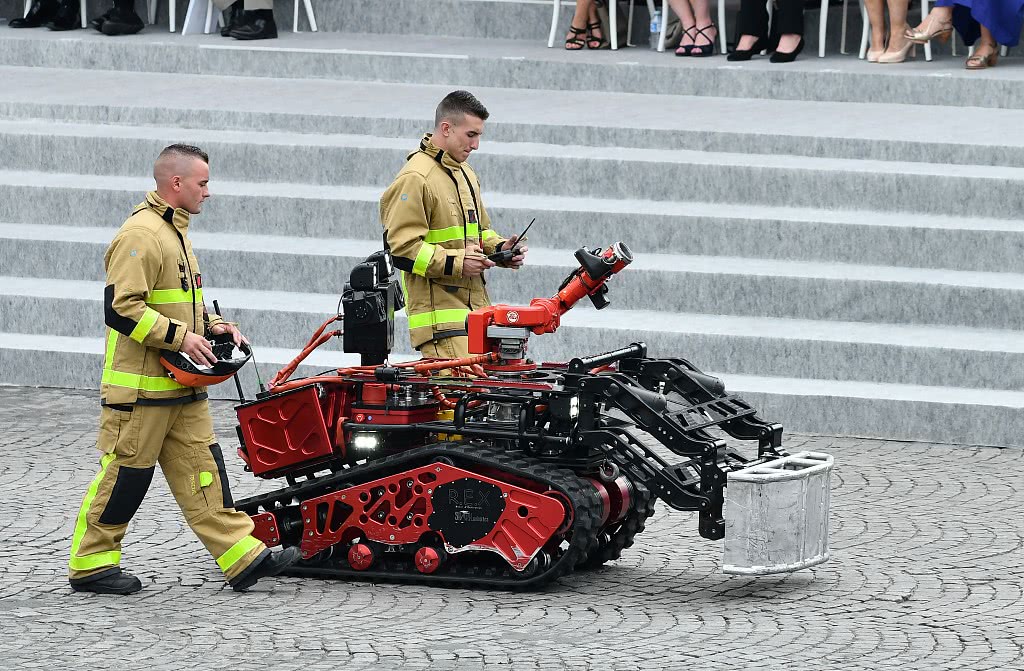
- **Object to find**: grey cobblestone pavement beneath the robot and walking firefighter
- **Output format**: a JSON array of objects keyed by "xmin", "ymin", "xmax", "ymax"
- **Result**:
[{"xmin": 0, "ymin": 387, "xmax": 1024, "ymax": 671}]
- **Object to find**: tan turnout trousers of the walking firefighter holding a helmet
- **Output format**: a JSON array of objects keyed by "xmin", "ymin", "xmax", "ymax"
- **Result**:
[{"xmin": 69, "ymin": 401, "xmax": 266, "ymax": 580}]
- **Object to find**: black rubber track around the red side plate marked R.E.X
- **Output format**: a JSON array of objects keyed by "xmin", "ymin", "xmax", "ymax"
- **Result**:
[{"xmin": 236, "ymin": 443, "xmax": 602, "ymax": 589}]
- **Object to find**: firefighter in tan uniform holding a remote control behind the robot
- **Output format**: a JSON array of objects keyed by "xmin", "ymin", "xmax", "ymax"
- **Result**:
[{"xmin": 381, "ymin": 91, "xmax": 527, "ymax": 359}]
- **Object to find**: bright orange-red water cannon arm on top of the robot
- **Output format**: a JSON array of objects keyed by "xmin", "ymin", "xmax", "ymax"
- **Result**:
[{"xmin": 468, "ymin": 242, "xmax": 633, "ymax": 362}]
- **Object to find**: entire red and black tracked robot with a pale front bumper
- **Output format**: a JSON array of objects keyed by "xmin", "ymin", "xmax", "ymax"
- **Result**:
[{"xmin": 236, "ymin": 243, "xmax": 831, "ymax": 588}]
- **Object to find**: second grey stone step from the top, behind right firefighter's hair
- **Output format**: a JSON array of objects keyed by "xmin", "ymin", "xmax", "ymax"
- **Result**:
[{"xmin": 6, "ymin": 67, "xmax": 1024, "ymax": 166}]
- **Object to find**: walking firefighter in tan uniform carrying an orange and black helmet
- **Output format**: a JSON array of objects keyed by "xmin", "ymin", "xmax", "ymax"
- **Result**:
[{"xmin": 69, "ymin": 144, "xmax": 299, "ymax": 594}]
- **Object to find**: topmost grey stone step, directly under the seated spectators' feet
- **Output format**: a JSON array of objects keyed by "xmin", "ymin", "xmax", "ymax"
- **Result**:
[{"xmin": 0, "ymin": 29, "xmax": 1024, "ymax": 110}]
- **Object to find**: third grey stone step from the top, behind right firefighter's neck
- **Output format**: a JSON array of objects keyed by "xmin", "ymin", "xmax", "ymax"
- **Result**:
[{"xmin": 0, "ymin": 121, "xmax": 1024, "ymax": 218}]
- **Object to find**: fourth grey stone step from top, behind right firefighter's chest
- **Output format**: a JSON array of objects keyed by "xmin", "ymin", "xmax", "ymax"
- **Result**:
[{"xmin": 0, "ymin": 170, "xmax": 1024, "ymax": 272}]
